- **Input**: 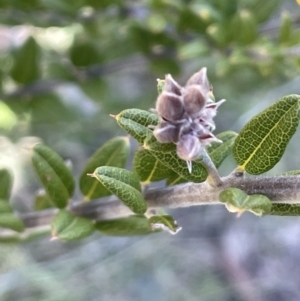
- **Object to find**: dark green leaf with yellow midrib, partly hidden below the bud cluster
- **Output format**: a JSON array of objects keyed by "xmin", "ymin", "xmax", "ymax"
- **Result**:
[{"xmin": 133, "ymin": 149, "xmax": 173, "ymax": 184}]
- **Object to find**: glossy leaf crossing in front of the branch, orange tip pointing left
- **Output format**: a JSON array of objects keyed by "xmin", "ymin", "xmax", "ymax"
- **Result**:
[{"xmin": 93, "ymin": 166, "xmax": 147, "ymax": 214}]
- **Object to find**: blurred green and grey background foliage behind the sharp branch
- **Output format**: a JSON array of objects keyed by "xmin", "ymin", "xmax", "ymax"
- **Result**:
[{"xmin": 0, "ymin": 0, "xmax": 300, "ymax": 301}]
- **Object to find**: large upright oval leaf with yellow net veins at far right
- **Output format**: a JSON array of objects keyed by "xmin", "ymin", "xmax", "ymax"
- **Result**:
[{"xmin": 233, "ymin": 95, "xmax": 300, "ymax": 174}]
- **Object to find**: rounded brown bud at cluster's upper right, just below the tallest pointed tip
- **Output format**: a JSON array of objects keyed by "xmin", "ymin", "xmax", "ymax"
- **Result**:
[{"xmin": 183, "ymin": 85, "xmax": 208, "ymax": 118}]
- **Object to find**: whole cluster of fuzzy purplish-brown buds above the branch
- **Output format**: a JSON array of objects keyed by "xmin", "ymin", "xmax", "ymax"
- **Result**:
[{"xmin": 153, "ymin": 68, "xmax": 225, "ymax": 172}]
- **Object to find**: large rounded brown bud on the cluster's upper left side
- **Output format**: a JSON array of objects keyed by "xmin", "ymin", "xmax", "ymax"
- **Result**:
[{"xmin": 156, "ymin": 92, "xmax": 184, "ymax": 124}]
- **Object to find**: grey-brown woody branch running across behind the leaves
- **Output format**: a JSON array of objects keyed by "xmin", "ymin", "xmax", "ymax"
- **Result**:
[{"xmin": 19, "ymin": 173, "xmax": 300, "ymax": 228}]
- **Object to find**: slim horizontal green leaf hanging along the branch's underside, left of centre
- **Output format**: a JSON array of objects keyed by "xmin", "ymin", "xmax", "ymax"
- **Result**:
[{"xmin": 95, "ymin": 215, "xmax": 161, "ymax": 236}]
